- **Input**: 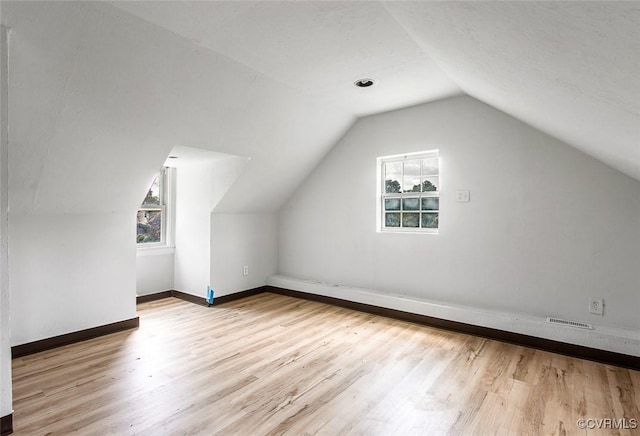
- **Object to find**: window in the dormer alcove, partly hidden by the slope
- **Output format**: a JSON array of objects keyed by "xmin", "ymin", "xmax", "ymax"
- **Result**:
[{"xmin": 136, "ymin": 167, "xmax": 169, "ymax": 245}]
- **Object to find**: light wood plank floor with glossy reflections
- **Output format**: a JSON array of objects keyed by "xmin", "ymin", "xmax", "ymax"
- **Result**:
[{"xmin": 13, "ymin": 294, "xmax": 640, "ymax": 436}]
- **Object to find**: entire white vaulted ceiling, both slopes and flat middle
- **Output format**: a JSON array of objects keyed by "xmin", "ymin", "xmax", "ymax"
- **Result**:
[{"xmin": 0, "ymin": 1, "xmax": 640, "ymax": 212}]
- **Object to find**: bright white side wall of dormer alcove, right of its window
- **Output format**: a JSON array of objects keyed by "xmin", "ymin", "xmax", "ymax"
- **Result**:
[{"xmin": 174, "ymin": 156, "xmax": 249, "ymax": 297}]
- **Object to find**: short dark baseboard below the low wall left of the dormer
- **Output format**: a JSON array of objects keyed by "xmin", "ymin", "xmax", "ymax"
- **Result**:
[{"xmin": 11, "ymin": 316, "xmax": 140, "ymax": 359}]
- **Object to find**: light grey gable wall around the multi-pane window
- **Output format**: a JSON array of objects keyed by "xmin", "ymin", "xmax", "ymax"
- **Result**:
[{"xmin": 279, "ymin": 97, "xmax": 640, "ymax": 348}]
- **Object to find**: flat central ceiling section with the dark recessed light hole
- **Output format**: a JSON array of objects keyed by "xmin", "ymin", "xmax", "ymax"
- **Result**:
[{"xmin": 113, "ymin": 1, "xmax": 460, "ymax": 116}]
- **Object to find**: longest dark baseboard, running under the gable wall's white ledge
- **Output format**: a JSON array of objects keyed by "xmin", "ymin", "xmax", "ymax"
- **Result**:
[{"xmin": 264, "ymin": 286, "xmax": 640, "ymax": 371}]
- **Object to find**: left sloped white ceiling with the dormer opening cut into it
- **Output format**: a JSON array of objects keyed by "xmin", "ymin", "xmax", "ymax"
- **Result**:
[{"xmin": 2, "ymin": 1, "xmax": 353, "ymax": 214}]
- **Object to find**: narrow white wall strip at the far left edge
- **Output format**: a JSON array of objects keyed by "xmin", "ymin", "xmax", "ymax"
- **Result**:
[{"xmin": 0, "ymin": 23, "xmax": 12, "ymax": 417}]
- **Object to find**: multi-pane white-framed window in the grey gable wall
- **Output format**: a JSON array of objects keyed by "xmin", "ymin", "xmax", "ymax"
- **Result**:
[{"xmin": 377, "ymin": 150, "xmax": 440, "ymax": 233}]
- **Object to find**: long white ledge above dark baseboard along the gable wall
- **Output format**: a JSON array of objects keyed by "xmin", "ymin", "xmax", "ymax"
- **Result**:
[{"xmin": 267, "ymin": 275, "xmax": 640, "ymax": 357}]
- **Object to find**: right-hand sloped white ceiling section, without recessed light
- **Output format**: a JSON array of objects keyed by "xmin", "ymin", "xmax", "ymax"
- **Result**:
[{"xmin": 385, "ymin": 2, "xmax": 640, "ymax": 179}]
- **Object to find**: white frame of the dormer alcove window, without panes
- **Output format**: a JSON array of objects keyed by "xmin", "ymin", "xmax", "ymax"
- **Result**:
[{"xmin": 136, "ymin": 167, "xmax": 175, "ymax": 250}]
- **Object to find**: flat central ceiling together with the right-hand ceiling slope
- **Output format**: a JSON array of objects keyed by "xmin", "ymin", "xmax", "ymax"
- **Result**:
[{"xmin": 112, "ymin": 1, "xmax": 640, "ymax": 179}]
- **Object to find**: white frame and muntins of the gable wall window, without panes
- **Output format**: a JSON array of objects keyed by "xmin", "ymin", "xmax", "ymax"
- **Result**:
[{"xmin": 376, "ymin": 149, "xmax": 442, "ymax": 235}]
